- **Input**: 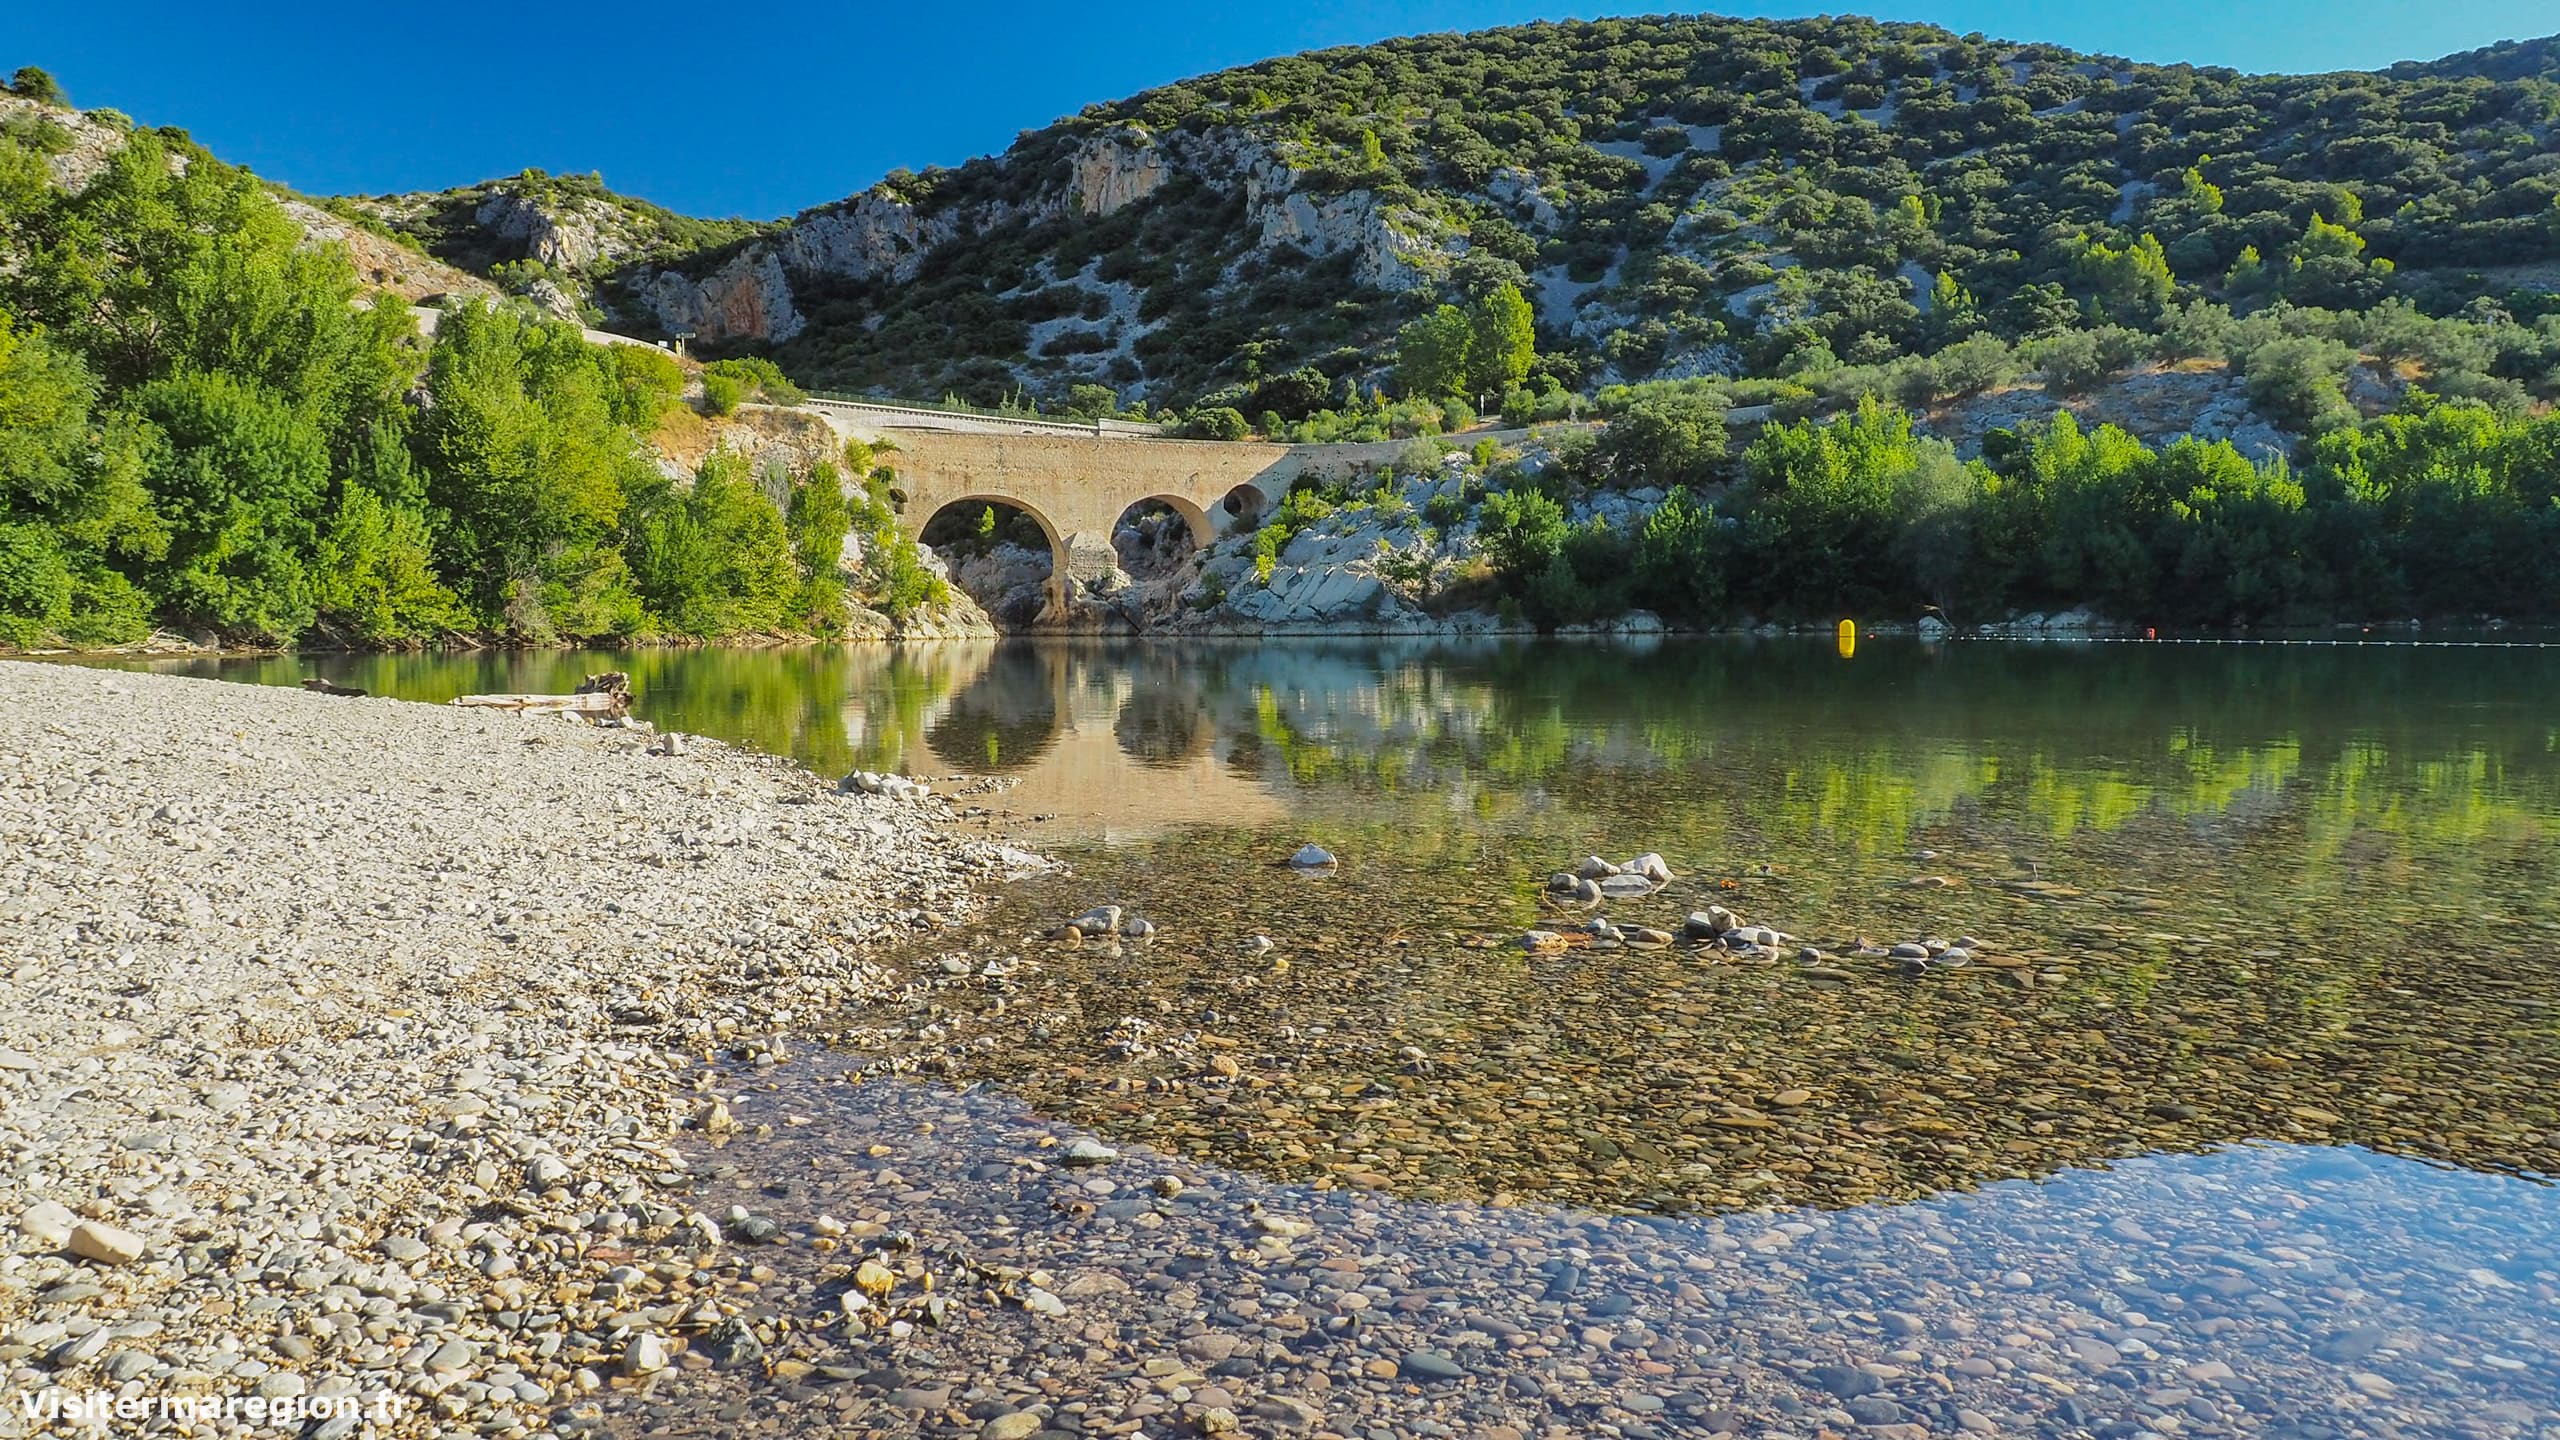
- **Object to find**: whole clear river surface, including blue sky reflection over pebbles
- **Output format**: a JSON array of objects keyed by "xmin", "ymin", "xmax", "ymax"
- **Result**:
[{"xmin": 115, "ymin": 641, "xmax": 2560, "ymax": 1435}]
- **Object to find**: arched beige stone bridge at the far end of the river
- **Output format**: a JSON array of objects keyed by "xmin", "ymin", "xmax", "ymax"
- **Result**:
[{"xmin": 809, "ymin": 400, "xmax": 1495, "ymax": 615}]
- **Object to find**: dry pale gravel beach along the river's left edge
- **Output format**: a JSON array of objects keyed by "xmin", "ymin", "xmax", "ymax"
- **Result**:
[{"xmin": 0, "ymin": 664, "xmax": 1037, "ymax": 1435}]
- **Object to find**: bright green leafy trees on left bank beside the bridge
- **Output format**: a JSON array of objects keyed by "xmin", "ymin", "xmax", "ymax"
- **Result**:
[{"xmin": 0, "ymin": 69, "xmax": 932, "ymax": 646}]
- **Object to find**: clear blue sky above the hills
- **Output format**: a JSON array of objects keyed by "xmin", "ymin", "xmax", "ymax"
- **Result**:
[{"xmin": 0, "ymin": 0, "xmax": 2560, "ymax": 218}]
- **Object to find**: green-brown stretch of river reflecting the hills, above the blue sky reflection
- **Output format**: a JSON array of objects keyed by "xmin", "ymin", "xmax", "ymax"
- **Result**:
[{"xmin": 124, "ymin": 641, "xmax": 2560, "ymax": 1209}]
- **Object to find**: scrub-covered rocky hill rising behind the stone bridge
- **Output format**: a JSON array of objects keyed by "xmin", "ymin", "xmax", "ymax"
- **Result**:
[{"xmin": 335, "ymin": 15, "xmax": 2560, "ymax": 405}]
